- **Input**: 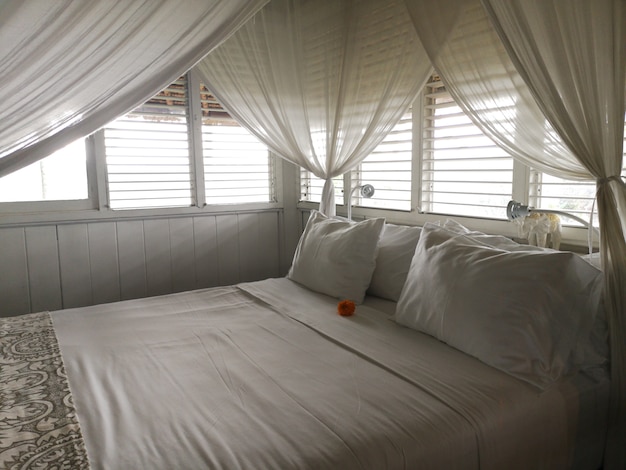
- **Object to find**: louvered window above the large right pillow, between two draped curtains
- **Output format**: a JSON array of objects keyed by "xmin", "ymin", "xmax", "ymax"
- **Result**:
[{"xmin": 421, "ymin": 76, "xmax": 513, "ymax": 219}]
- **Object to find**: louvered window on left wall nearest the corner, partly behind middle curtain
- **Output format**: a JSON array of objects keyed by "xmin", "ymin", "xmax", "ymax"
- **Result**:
[{"xmin": 200, "ymin": 85, "xmax": 275, "ymax": 204}]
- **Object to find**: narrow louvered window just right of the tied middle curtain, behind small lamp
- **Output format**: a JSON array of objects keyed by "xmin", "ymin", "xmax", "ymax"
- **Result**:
[{"xmin": 351, "ymin": 110, "xmax": 413, "ymax": 211}]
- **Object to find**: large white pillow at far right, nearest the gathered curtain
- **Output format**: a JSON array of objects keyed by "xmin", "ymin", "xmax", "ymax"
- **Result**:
[{"xmin": 394, "ymin": 224, "xmax": 601, "ymax": 388}]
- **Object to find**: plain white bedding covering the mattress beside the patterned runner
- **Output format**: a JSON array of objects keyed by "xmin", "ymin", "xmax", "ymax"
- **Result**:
[{"xmin": 51, "ymin": 279, "xmax": 606, "ymax": 469}]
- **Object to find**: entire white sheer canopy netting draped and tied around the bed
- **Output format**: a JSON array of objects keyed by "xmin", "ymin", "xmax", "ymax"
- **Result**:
[{"xmin": 0, "ymin": 0, "xmax": 626, "ymax": 469}]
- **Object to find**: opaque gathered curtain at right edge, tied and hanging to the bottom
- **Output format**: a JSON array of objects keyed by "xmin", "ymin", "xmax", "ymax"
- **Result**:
[{"xmin": 484, "ymin": 0, "xmax": 626, "ymax": 469}]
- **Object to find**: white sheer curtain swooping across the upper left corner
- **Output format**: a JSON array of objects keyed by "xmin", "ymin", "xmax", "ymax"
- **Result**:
[{"xmin": 0, "ymin": 0, "xmax": 268, "ymax": 176}]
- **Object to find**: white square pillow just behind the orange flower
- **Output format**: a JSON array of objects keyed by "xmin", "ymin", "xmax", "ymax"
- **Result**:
[{"xmin": 287, "ymin": 211, "xmax": 385, "ymax": 304}]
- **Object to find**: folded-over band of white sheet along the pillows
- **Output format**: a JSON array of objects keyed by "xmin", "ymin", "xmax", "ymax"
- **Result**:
[{"xmin": 242, "ymin": 280, "xmax": 609, "ymax": 469}]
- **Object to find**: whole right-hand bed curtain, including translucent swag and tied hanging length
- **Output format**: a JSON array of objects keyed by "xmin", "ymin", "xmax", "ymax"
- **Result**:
[{"xmin": 406, "ymin": 0, "xmax": 626, "ymax": 469}]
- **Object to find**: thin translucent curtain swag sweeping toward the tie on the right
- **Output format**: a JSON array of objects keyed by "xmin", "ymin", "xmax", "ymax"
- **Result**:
[{"xmin": 406, "ymin": 0, "xmax": 590, "ymax": 179}]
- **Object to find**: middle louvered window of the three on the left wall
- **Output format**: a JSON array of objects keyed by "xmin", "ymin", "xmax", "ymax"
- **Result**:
[{"xmin": 104, "ymin": 77, "xmax": 193, "ymax": 209}]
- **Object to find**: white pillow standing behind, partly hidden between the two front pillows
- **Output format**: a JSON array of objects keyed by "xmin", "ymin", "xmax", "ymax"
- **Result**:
[{"xmin": 367, "ymin": 224, "xmax": 422, "ymax": 302}]
